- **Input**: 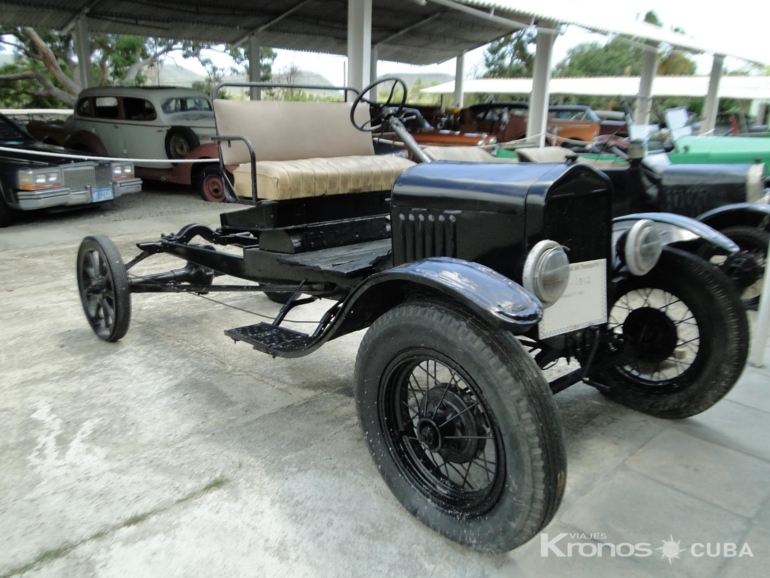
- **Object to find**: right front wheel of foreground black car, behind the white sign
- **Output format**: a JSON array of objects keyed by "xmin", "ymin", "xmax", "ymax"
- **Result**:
[{"xmin": 597, "ymin": 247, "xmax": 749, "ymax": 419}]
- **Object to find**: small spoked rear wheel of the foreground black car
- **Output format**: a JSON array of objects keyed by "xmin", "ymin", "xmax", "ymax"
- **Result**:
[{"xmin": 77, "ymin": 235, "xmax": 131, "ymax": 341}]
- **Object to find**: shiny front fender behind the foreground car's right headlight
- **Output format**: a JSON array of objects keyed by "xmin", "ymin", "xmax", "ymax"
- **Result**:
[{"xmin": 612, "ymin": 213, "xmax": 739, "ymax": 253}]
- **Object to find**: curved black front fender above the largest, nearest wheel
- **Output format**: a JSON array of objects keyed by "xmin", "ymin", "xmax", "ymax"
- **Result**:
[{"xmin": 333, "ymin": 257, "xmax": 543, "ymax": 338}]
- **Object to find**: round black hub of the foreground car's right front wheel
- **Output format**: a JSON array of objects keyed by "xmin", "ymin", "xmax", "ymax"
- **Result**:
[{"xmin": 623, "ymin": 307, "xmax": 678, "ymax": 363}]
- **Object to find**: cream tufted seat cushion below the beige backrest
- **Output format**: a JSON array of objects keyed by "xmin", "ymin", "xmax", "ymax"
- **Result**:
[{"xmin": 234, "ymin": 155, "xmax": 414, "ymax": 201}]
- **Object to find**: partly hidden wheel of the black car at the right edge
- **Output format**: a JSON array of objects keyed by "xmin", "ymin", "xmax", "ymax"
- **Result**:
[{"xmin": 698, "ymin": 226, "xmax": 770, "ymax": 309}]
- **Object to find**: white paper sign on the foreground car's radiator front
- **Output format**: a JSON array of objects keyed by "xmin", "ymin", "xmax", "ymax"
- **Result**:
[{"xmin": 538, "ymin": 259, "xmax": 607, "ymax": 339}]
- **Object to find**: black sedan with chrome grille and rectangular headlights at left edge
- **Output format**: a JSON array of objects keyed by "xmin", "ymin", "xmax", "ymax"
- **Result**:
[{"xmin": 0, "ymin": 115, "xmax": 142, "ymax": 227}]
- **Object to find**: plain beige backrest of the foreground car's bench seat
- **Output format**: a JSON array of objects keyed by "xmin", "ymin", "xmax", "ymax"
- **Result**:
[{"xmin": 214, "ymin": 99, "xmax": 374, "ymax": 165}]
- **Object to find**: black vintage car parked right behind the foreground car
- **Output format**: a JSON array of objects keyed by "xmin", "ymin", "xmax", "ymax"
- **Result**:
[{"xmin": 497, "ymin": 143, "xmax": 770, "ymax": 309}]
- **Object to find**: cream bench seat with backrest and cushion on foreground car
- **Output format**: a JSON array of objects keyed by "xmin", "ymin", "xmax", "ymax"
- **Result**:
[{"xmin": 214, "ymin": 100, "xmax": 414, "ymax": 200}]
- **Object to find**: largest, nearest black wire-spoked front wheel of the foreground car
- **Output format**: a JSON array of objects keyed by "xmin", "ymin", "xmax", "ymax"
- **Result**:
[{"xmin": 355, "ymin": 301, "xmax": 567, "ymax": 552}]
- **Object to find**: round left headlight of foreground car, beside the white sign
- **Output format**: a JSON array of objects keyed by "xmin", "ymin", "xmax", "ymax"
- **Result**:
[{"xmin": 524, "ymin": 240, "xmax": 569, "ymax": 307}]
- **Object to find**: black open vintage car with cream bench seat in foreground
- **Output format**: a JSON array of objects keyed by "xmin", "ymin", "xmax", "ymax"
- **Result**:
[{"xmin": 72, "ymin": 79, "xmax": 748, "ymax": 552}]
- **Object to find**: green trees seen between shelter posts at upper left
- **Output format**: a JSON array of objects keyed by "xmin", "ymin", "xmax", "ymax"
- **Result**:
[{"xmin": 0, "ymin": 26, "xmax": 275, "ymax": 108}]
